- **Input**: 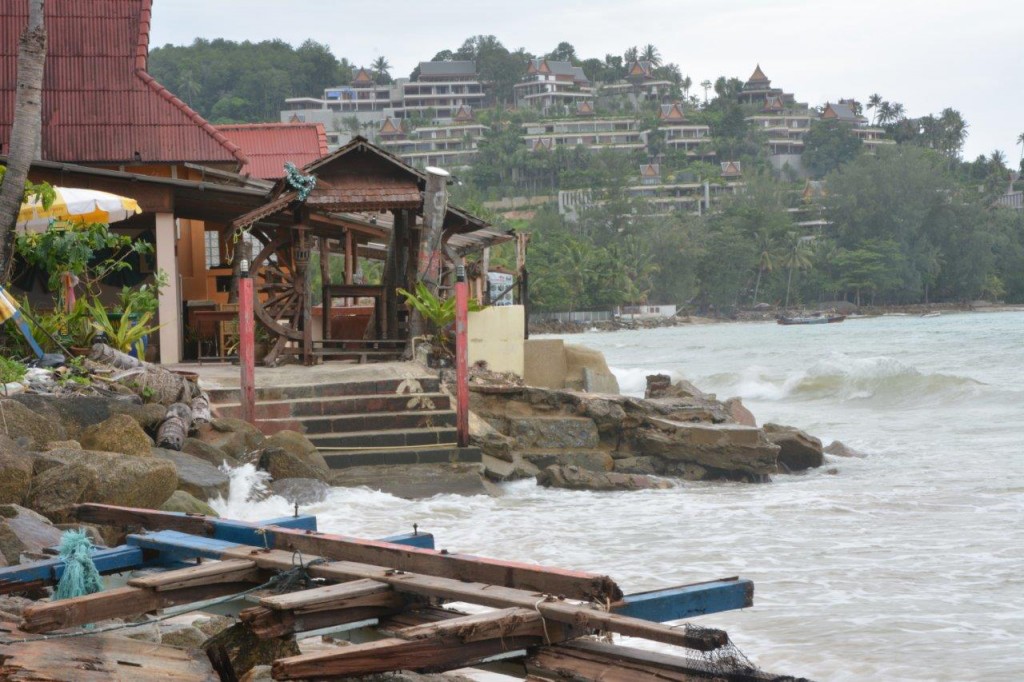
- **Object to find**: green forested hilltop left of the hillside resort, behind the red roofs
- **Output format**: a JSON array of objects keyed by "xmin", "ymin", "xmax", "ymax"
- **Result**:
[{"xmin": 150, "ymin": 38, "xmax": 352, "ymax": 123}]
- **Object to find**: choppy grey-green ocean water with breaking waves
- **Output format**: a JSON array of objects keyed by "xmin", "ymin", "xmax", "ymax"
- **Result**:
[{"xmin": 211, "ymin": 312, "xmax": 1024, "ymax": 681}]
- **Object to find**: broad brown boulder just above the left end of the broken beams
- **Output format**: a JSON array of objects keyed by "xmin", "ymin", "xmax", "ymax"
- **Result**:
[{"xmin": 27, "ymin": 450, "xmax": 178, "ymax": 522}]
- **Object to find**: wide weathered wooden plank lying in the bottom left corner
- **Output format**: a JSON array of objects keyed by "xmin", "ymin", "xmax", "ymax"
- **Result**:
[{"xmin": 0, "ymin": 624, "xmax": 220, "ymax": 682}]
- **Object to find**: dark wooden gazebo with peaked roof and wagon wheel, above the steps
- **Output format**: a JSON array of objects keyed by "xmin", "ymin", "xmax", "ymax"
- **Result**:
[{"xmin": 231, "ymin": 137, "xmax": 513, "ymax": 365}]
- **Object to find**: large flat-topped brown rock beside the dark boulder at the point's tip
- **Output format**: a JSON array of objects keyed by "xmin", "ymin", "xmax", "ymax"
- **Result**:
[{"xmin": 634, "ymin": 418, "xmax": 779, "ymax": 481}]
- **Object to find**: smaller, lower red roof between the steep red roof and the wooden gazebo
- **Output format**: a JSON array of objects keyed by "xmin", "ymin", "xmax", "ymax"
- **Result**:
[{"xmin": 216, "ymin": 123, "xmax": 328, "ymax": 180}]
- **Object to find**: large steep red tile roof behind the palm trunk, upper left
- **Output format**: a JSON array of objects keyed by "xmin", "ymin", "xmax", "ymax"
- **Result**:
[{"xmin": 0, "ymin": 0, "xmax": 246, "ymax": 164}]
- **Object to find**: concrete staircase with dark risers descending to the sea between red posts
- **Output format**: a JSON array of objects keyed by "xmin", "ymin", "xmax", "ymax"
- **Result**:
[{"xmin": 208, "ymin": 376, "xmax": 480, "ymax": 469}]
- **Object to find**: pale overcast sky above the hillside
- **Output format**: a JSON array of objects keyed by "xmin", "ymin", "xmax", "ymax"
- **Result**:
[{"xmin": 151, "ymin": 0, "xmax": 1024, "ymax": 161}]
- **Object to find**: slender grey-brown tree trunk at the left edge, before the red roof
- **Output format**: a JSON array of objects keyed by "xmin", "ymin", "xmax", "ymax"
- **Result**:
[{"xmin": 0, "ymin": 0, "xmax": 46, "ymax": 285}]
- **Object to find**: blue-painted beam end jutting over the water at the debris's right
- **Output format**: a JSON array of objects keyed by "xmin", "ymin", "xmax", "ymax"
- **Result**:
[{"xmin": 611, "ymin": 578, "xmax": 754, "ymax": 623}]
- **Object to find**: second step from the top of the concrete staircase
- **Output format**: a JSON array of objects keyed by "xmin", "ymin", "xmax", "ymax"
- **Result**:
[{"xmin": 212, "ymin": 393, "xmax": 452, "ymax": 420}]
